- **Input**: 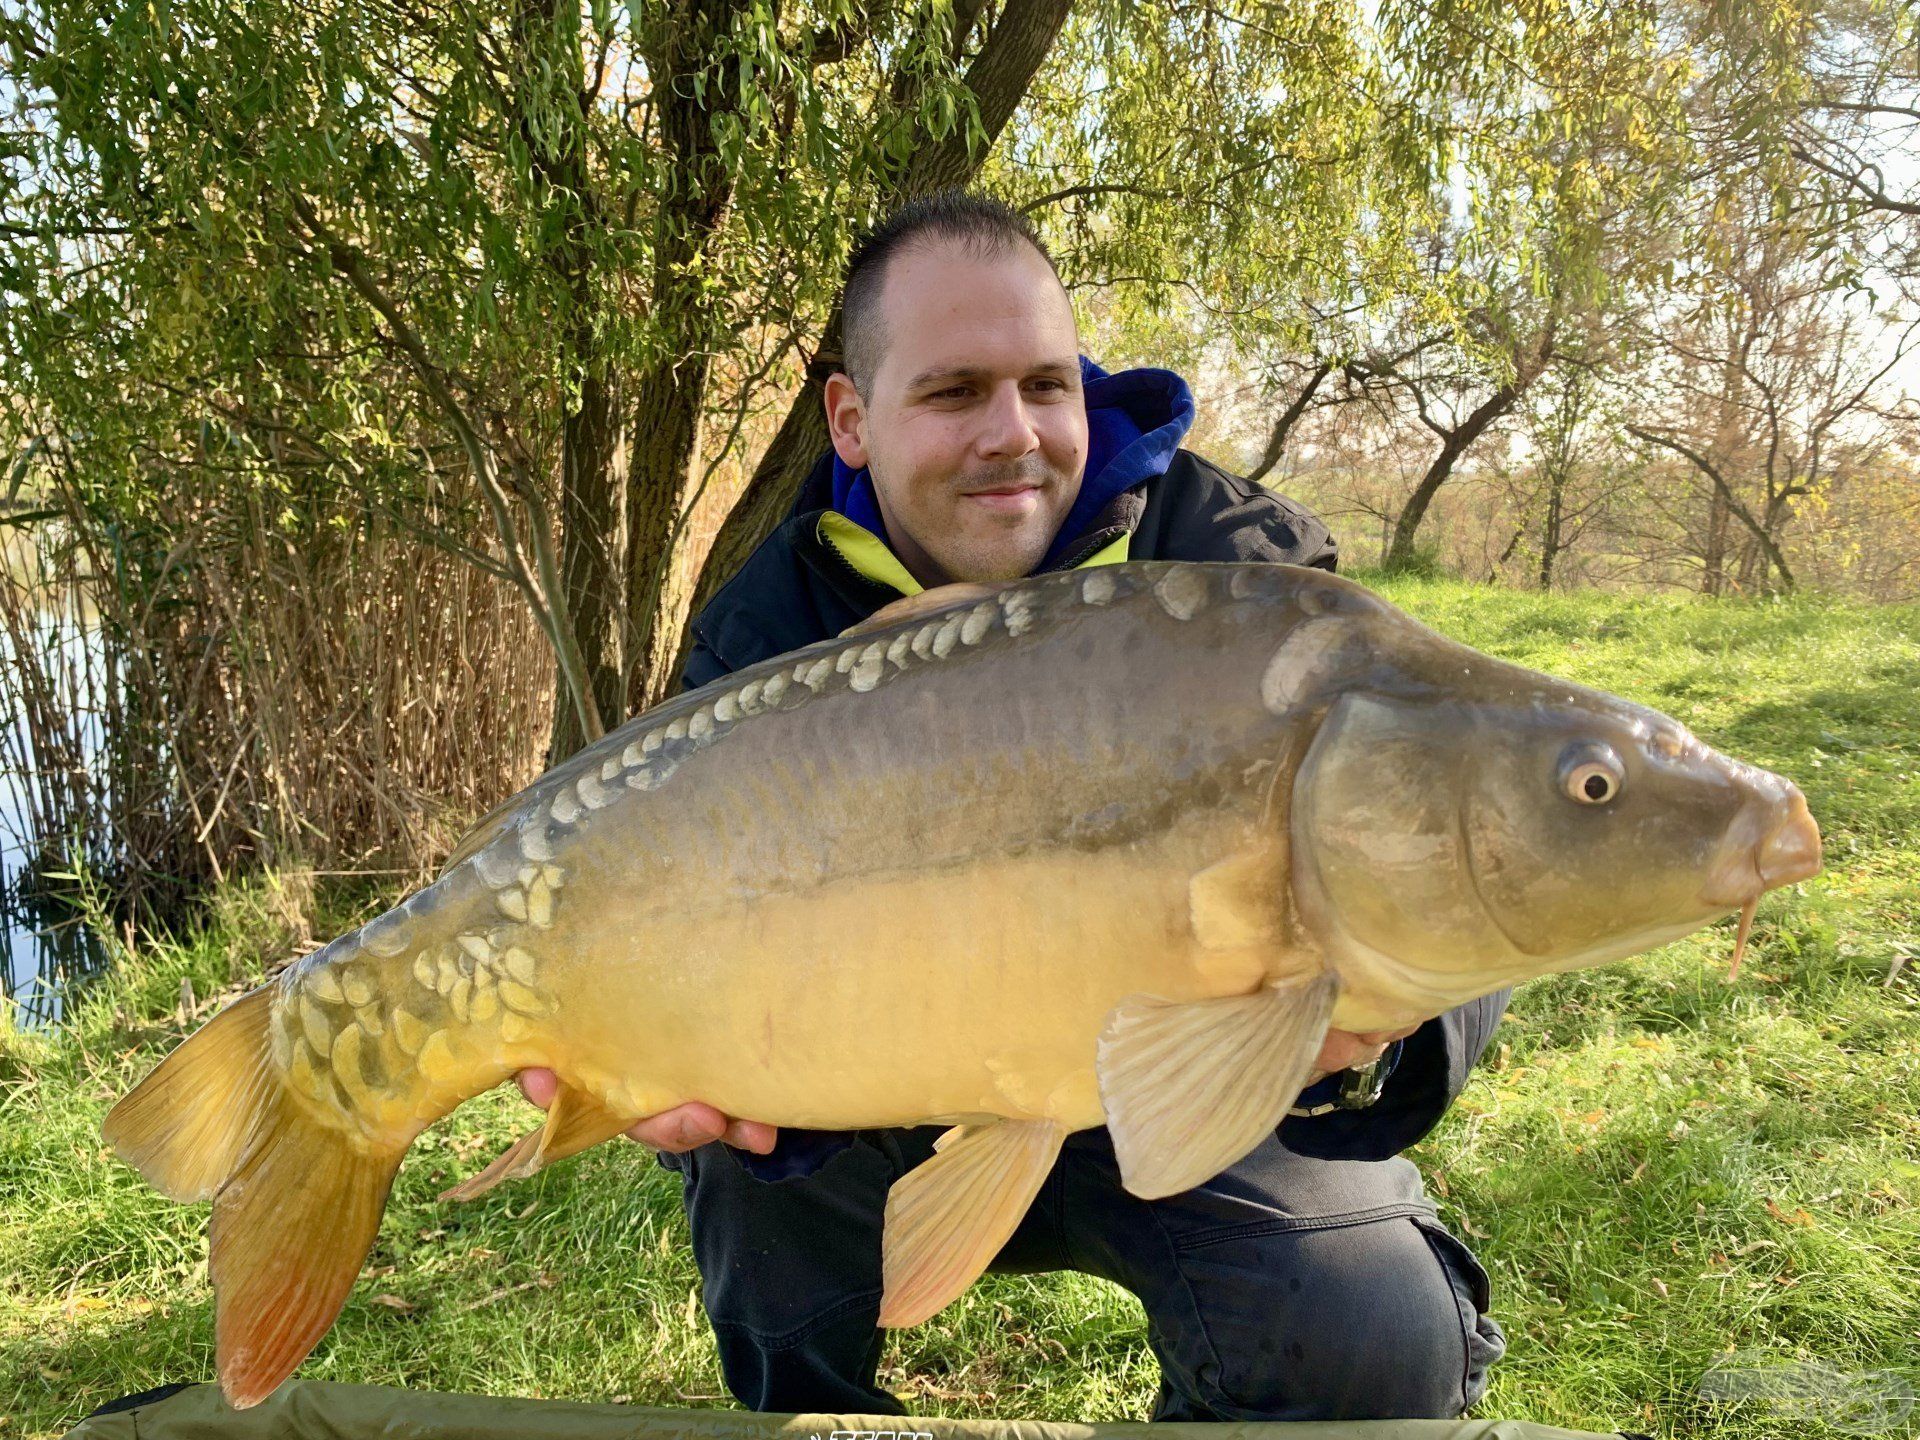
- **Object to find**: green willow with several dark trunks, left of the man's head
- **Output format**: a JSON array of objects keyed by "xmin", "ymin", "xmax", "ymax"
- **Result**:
[{"xmin": 0, "ymin": 0, "xmax": 1068, "ymax": 753}]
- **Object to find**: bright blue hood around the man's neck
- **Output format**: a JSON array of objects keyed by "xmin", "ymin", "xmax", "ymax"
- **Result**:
[{"xmin": 793, "ymin": 355, "xmax": 1194, "ymax": 570}]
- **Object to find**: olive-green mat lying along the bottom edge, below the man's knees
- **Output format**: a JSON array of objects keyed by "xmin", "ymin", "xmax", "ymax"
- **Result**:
[{"xmin": 69, "ymin": 1380, "xmax": 1651, "ymax": 1440}]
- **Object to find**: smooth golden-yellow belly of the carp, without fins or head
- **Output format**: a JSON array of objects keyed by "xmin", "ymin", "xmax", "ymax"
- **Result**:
[{"xmin": 555, "ymin": 824, "xmax": 1277, "ymax": 1129}]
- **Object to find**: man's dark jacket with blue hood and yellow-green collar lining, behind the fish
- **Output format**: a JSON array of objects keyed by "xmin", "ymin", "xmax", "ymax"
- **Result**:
[{"xmin": 684, "ymin": 357, "xmax": 1511, "ymax": 1179}]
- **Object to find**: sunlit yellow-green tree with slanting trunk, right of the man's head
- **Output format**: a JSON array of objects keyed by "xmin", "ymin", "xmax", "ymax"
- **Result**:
[{"xmin": 1021, "ymin": 0, "xmax": 1843, "ymax": 576}]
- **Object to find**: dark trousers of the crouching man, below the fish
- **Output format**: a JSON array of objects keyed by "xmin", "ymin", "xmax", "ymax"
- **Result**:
[{"xmin": 660, "ymin": 1125, "xmax": 1507, "ymax": 1421}]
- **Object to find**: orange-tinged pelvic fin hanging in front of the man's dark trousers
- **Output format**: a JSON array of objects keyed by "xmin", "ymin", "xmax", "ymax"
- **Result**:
[{"xmin": 879, "ymin": 1119, "xmax": 1068, "ymax": 1327}]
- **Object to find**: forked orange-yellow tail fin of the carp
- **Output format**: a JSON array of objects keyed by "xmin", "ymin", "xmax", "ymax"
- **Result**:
[{"xmin": 106, "ymin": 987, "xmax": 407, "ymax": 1409}]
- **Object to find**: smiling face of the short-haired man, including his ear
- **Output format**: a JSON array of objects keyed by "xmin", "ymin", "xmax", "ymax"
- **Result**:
[{"xmin": 826, "ymin": 242, "xmax": 1087, "ymax": 586}]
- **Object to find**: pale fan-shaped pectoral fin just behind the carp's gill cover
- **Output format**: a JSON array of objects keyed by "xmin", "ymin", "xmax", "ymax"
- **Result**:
[{"xmin": 1098, "ymin": 973, "xmax": 1340, "ymax": 1200}]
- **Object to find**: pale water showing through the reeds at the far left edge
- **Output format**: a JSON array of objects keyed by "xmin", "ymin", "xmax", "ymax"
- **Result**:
[{"xmin": 0, "ymin": 616, "xmax": 108, "ymax": 1027}]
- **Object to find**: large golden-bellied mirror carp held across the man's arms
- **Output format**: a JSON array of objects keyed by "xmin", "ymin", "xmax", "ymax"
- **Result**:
[{"xmin": 106, "ymin": 563, "xmax": 1820, "ymax": 1405}]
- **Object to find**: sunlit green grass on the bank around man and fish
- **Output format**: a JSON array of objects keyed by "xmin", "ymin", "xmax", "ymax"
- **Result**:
[{"xmin": 0, "ymin": 578, "xmax": 1920, "ymax": 1440}]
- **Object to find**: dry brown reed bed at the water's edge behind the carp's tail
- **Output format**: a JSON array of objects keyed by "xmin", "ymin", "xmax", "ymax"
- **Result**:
[{"xmin": 0, "ymin": 451, "xmax": 553, "ymax": 960}]
